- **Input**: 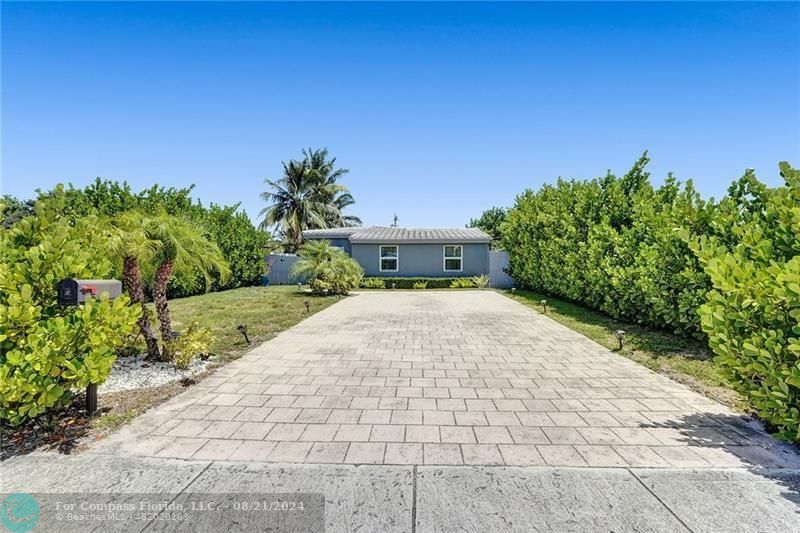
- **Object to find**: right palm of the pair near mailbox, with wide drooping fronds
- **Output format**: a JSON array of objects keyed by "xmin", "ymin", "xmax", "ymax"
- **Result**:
[{"xmin": 145, "ymin": 213, "xmax": 230, "ymax": 361}]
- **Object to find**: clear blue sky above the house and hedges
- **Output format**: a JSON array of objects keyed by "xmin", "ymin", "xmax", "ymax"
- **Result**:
[{"xmin": 2, "ymin": 2, "xmax": 800, "ymax": 227}]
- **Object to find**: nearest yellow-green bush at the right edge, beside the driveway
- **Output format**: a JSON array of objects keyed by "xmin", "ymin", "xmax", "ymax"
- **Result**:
[{"xmin": 692, "ymin": 163, "xmax": 800, "ymax": 442}]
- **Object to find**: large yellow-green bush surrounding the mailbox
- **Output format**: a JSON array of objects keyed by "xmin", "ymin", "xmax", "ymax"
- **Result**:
[{"xmin": 0, "ymin": 188, "xmax": 139, "ymax": 424}]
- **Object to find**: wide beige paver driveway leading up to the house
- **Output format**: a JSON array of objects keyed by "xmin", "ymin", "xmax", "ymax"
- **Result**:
[{"xmin": 101, "ymin": 291, "xmax": 800, "ymax": 468}]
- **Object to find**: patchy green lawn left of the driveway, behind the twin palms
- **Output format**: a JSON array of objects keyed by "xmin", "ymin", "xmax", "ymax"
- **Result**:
[{"xmin": 162, "ymin": 285, "xmax": 338, "ymax": 359}]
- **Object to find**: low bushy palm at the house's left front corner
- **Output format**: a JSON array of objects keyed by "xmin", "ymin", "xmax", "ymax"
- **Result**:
[{"xmin": 291, "ymin": 241, "xmax": 364, "ymax": 295}]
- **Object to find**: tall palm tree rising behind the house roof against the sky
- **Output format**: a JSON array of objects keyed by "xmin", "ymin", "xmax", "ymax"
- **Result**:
[{"xmin": 260, "ymin": 148, "xmax": 361, "ymax": 252}]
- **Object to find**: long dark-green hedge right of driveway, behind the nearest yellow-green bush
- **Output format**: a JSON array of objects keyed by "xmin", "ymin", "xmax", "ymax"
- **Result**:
[{"xmin": 502, "ymin": 156, "xmax": 712, "ymax": 338}]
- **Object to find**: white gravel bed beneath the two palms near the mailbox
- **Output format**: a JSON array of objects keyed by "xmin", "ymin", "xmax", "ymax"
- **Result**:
[{"xmin": 97, "ymin": 354, "xmax": 214, "ymax": 392}]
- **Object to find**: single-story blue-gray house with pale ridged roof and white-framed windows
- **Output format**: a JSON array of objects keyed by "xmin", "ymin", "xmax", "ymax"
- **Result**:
[{"xmin": 303, "ymin": 227, "xmax": 491, "ymax": 278}]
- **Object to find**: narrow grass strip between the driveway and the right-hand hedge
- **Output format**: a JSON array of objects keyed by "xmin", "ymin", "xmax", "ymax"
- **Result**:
[{"xmin": 502, "ymin": 290, "xmax": 750, "ymax": 412}]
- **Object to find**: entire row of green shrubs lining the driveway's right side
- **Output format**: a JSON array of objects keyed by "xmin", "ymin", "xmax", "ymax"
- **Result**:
[{"xmin": 502, "ymin": 154, "xmax": 800, "ymax": 441}]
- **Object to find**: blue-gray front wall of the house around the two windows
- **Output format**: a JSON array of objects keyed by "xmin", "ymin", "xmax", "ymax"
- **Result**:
[{"xmin": 350, "ymin": 242, "xmax": 489, "ymax": 278}]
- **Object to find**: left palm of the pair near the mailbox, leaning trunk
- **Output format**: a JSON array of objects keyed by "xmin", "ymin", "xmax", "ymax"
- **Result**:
[{"xmin": 110, "ymin": 211, "xmax": 161, "ymax": 359}]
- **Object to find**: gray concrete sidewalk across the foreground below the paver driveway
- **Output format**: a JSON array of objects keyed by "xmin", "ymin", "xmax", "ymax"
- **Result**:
[{"xmin": 0, "ymin": 454, "xmax": 800, "ymax": 532}]
